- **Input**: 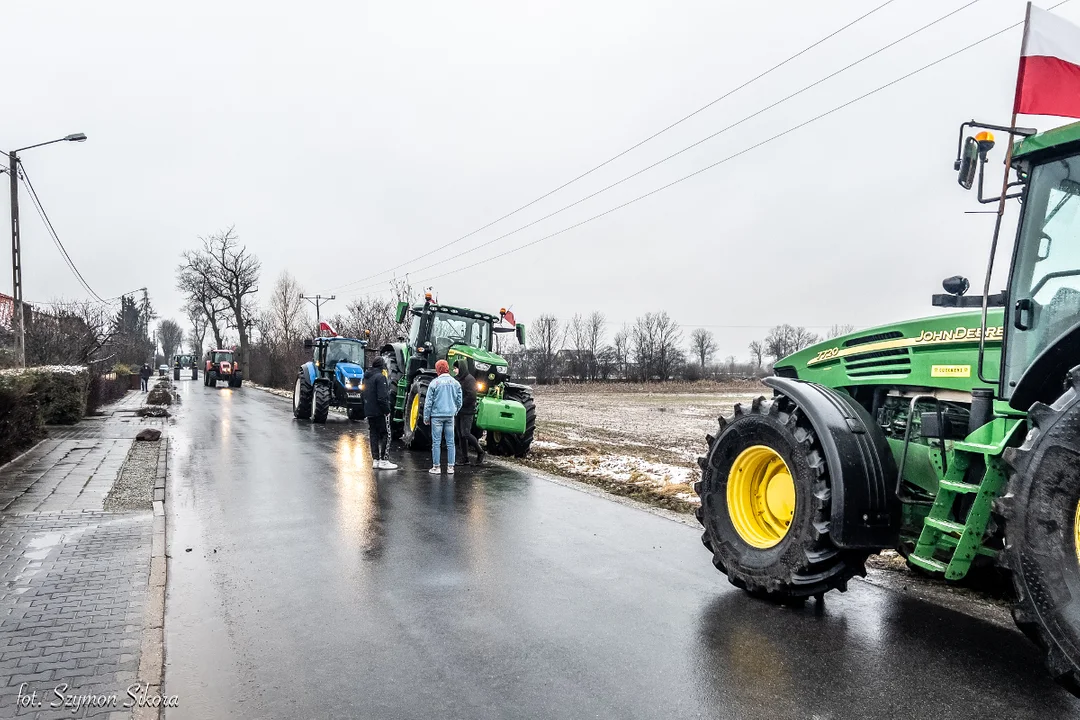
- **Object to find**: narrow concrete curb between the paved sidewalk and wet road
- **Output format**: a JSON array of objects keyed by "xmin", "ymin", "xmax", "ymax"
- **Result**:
[{"xmin": 132, "ymin": 435, "xmax": 168, "ymax": 720}]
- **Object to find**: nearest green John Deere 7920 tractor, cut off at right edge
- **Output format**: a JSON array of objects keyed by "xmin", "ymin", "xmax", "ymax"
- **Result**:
[{"xmin": 696, "ymin": 121, "xmax": 1080, "ymax": 694}]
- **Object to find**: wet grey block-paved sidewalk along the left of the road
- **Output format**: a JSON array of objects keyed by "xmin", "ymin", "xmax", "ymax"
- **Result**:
[{"xmin": 0, "ymin": 392, "xmax": 167, "ymax": 720}]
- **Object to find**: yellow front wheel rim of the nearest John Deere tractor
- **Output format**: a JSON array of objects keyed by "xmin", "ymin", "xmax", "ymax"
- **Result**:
[{"xmin": 728, "ymin": 445, "xmax": 794, "ymax": 549}]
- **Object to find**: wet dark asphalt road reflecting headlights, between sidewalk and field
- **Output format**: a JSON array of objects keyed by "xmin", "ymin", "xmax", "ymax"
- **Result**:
[{"xmin": 165, "ymin": 381, "xmax": 1080, "ymax": 720}]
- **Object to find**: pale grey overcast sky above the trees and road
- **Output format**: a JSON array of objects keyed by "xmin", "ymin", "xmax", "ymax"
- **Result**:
[{"xmin": 0, "ymin": 0, "xmax": 1080, "ymax": 358}]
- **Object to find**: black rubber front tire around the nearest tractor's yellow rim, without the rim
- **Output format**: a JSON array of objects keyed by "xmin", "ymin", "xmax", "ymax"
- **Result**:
[{"xmin": 694, "ymin": 394, "xmax": 867, "ymax": 601}]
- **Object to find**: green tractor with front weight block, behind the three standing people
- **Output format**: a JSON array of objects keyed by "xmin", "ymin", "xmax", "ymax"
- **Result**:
[{"xmin": 379, "ymin": 294, "xmax": 537, "ymax": 457}]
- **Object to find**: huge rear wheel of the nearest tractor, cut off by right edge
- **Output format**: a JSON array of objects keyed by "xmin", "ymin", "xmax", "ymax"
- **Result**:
[{"xmin": 998, "ymin": 367, "xmax": 1080, "ymax": 695}]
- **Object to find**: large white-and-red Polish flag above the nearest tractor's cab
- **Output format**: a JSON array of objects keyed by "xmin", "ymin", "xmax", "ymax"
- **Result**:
[{"xmin": 1013, "ymin": 2, "xmax": 1080, "ymax": 118}]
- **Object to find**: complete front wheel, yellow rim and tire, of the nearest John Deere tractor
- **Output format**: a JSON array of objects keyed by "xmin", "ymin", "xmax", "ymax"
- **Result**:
[{"xmin": 694, "ymin": 395, "xmax": 867, "ymax": 601}]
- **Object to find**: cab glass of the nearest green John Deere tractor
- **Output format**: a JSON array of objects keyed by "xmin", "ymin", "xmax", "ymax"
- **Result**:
[{"xmin": 1003, "ymin": 155, "xmax": 1080, "ymax": 395}]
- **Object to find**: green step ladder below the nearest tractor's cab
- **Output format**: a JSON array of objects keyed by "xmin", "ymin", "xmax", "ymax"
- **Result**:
[{"xmin": 907, "ymin": 443, "xmax": 1005, "ymax": 580}]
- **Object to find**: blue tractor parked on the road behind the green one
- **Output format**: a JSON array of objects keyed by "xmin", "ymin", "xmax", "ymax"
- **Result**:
[{"xmin": 293, "ymin": 337, "xmax": 367, "ymax": 422}]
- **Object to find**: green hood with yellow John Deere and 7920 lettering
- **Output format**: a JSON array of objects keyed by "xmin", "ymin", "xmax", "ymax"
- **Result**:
[{"xmin": 774, "ymin": 309, "xmax": 1003, "ymax": 392}]
